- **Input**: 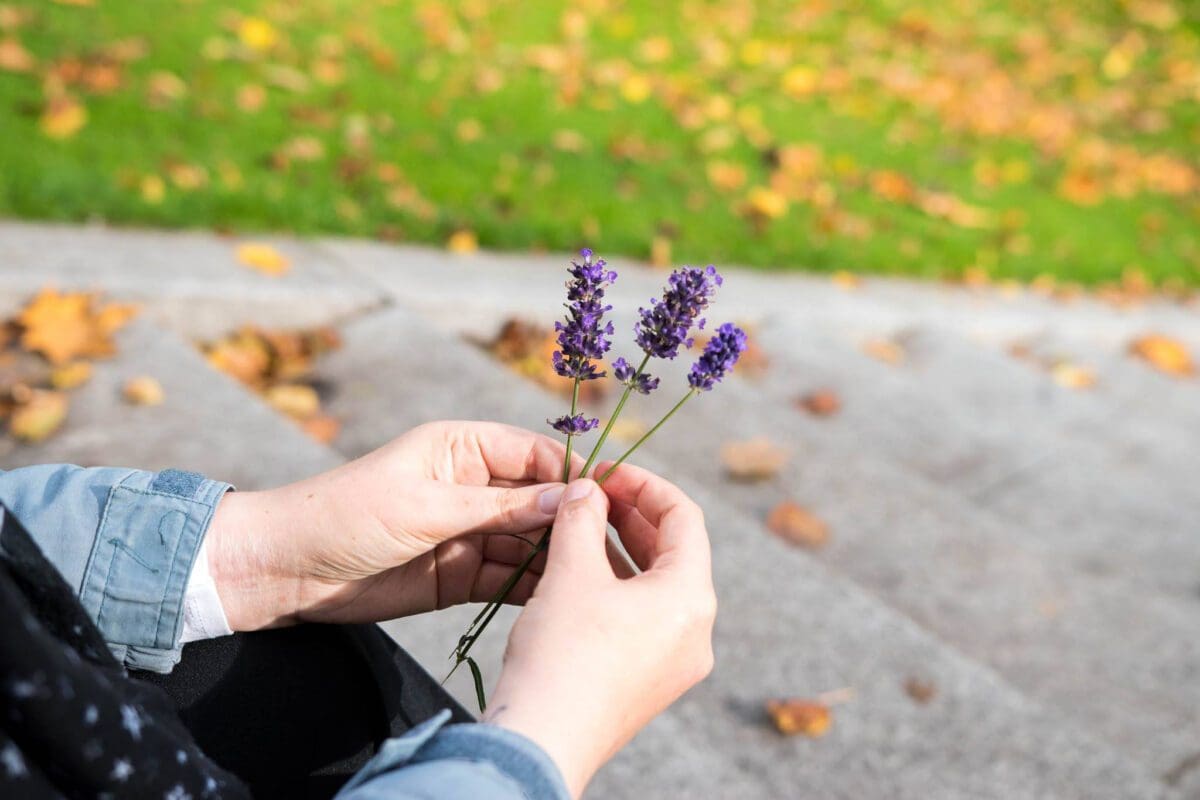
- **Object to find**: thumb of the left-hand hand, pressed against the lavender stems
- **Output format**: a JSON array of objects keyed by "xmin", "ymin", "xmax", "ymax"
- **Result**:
[{"xmin": 420, "ymin": 482, "xmax": 565, "ymax": 542}]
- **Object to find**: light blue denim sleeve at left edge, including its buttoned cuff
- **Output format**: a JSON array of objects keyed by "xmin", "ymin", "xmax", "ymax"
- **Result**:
[{"xmin": 0, "ymin": 464, "xmax": 232, "ymax": 673}]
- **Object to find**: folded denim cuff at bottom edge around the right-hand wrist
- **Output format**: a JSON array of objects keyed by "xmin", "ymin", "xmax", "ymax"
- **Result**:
[{"xmin": 338, "ymin": 710, "xmax": 571, "ymax": 800}]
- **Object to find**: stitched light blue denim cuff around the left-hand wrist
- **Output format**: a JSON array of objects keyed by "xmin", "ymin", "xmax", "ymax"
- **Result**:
[{"xmin": 79, "ymin": 469, "xmax": 232, "ymax": 673}]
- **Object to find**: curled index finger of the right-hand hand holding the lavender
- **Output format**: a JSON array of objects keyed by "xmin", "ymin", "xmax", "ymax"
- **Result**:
[{"xmin": 601, "ymin": 464, "xmax": 712, "ymax": 576}]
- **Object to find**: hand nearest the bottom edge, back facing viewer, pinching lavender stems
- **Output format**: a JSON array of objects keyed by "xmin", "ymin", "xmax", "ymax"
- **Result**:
[{"xmin": 484, "ymin": 464, "xmax": 716, "ymax": 796}]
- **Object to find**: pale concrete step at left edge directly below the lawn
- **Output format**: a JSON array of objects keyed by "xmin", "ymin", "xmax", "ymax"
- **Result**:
[{"xmin": 0, "ymin": 221, "xmax": 382, "ymax": 338}]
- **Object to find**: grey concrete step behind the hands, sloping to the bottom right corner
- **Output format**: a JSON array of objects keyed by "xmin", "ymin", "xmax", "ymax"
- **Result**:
[{"xmin": 312, "ymin": 304, "xmax": 1165, "ymax": 798}]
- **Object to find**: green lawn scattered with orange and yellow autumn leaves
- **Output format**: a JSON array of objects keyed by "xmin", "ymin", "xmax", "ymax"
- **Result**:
[{"xmin": 0, "ymin": 0, "xmax": 1200, "ymax": 287}]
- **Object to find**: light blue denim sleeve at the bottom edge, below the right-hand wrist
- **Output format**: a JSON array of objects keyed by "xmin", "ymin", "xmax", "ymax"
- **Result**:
[{"xmin": 336, "ymin": 711, "xmax": 571, "ymax": 800}]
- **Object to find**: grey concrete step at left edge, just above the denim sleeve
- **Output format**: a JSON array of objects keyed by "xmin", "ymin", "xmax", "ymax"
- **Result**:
[{"xmin": 0, "ymin": 319, "xmax": 343, "ymax": 489}]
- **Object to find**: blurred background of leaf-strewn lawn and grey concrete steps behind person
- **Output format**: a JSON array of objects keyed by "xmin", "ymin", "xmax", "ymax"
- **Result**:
[{"xmin": 0, "ymin": 0, "xmax": 1200, "ymax": 799}]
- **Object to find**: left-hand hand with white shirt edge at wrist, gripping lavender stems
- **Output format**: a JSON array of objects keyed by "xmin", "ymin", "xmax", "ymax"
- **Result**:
[{"xmin": 208, "ymin": 422, "xmax": 578, "ymax": 631}]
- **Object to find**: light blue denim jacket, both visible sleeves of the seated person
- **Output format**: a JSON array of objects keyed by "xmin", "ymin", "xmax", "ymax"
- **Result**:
[{"xmin": 0, "ymin": 464, "xmax": 570, "ymax": 800}]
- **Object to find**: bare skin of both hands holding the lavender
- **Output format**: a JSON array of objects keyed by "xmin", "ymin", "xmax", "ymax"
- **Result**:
[{"xmin": 208, "ymin": 422, "xmax": 716, "ymax": 796}]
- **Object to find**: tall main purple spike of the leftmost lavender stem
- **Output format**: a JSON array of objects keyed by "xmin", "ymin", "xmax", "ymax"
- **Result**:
[{"xmin": 551, "ymin": 248, "xmax": 617, "ymax": 380}]
